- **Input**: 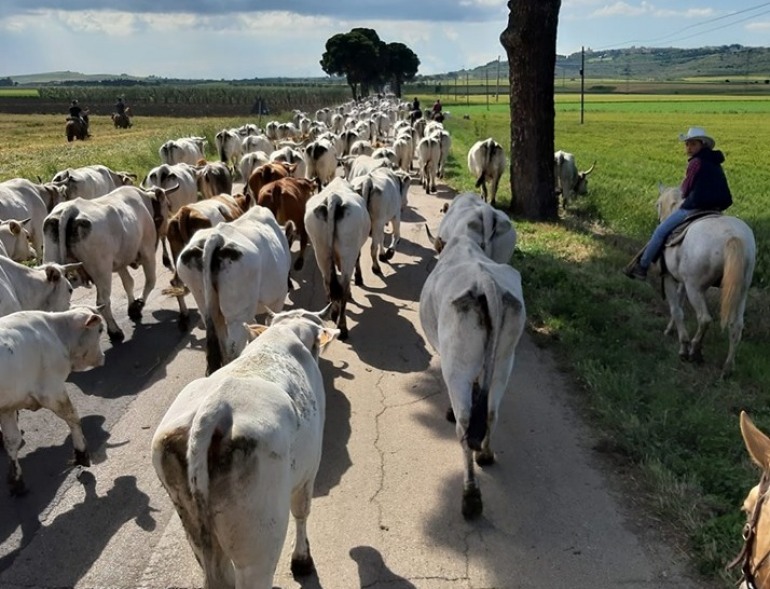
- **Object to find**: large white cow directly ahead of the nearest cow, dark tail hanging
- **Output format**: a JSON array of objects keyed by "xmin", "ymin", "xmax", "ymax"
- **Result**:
[{"xmin": 177, "ymin": 206, "xmax": 291, "ymax": 374}]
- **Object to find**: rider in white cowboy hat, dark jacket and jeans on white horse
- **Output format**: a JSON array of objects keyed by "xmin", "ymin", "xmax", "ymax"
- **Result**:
[{"xmin": 625, "ymin": 127, "xmax": 733, "ymax": 280}]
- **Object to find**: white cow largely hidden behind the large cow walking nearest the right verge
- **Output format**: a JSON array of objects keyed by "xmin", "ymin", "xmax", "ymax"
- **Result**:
[{"xmin": 426, "ymin": 192, "xmax": 516, "ymax": 264}]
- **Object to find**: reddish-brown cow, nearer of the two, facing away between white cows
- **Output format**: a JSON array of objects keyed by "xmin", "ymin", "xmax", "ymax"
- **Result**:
[{"xmin": 258, "ymin": 177, "xmax": 316, "ymax": 270}]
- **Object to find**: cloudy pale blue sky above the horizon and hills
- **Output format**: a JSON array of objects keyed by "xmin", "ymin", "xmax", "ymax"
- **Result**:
[{"xmin": 0, "ymin": 0, "xmax": 770, "ymax": 80}]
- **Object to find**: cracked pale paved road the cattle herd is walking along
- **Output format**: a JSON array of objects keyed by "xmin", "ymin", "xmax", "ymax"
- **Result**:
[{"xmin": 0, "ymin": 177, "xmax": 704, "ymax": 589}]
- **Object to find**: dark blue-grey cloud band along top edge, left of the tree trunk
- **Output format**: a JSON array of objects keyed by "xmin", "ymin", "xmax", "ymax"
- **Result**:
[{"xmin": 0, "ymin": 0, "xmax": 507, "ymax": 22}]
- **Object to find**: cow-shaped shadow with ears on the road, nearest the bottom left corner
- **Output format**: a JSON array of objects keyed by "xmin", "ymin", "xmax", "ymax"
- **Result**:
[{"xmin": 0, "ymin": 471, "xmax": 158, "ymax": 587}]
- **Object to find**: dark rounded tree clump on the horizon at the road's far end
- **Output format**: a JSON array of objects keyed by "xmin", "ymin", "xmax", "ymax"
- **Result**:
[{"xmin": 320, "ymin": 28, "xmax": 420, "ymax": 99}]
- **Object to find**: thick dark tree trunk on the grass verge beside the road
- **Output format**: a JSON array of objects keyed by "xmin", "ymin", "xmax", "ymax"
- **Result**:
[{"xmin": 500, "ymin": 0, "xmax": 561, "ymax": 221}]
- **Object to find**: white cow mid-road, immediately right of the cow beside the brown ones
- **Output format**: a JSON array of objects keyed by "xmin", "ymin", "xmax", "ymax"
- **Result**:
[{"xmin": 351, "ymin": 168, "xmax": 411, "ymax": 276}]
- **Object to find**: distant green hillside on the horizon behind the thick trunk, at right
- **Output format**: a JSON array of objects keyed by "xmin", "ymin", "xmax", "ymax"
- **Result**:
[{"xmin": 431, "ymin": 45, "xmax": 770, "ymax": 81}]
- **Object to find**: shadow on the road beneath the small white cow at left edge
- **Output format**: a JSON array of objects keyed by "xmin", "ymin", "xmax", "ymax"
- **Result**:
[{"xmin": 0, "ymin": 411, "xmax": 110, "ymax": 572}]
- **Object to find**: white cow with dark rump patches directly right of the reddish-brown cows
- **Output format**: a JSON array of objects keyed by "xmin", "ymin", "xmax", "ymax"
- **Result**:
[{"xmin": 305, "ymin": 177, "xmax": 372, "ymax": 340}]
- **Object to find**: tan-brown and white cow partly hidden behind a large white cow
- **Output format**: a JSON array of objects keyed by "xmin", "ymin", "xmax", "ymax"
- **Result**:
[{"xmin": 163, "ymin": 194, "xmax": 254, "ymax": 329}]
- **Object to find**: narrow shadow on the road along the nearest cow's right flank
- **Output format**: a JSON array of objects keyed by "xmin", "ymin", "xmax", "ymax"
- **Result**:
[{"xmin": 313, "ymin": 354, "xmax": 353, "ymax": 497}]
